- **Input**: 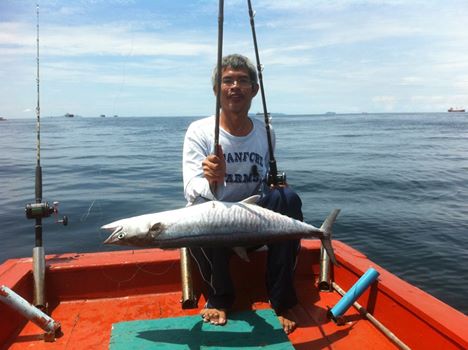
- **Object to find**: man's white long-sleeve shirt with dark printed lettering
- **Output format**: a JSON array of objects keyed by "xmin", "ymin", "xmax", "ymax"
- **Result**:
[{"xmin": 183, "ymin": 116, "xmax": 275, "ymax": 205}]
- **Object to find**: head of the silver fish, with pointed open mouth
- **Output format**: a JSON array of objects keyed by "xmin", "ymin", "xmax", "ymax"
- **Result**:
[{"xmin": 101, "ymin": 219, "xmax": 166, "ymax": 247}]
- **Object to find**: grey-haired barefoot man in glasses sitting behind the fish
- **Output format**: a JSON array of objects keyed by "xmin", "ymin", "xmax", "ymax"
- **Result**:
[{"xmin": 183, "ymin": 55, "xmax": 302, "ymax": 333}]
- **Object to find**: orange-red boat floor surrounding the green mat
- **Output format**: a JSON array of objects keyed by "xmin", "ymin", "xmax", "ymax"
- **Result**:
[{"xmin": 10, "ymin": 284, "xmax": 397, "ymax": 350}]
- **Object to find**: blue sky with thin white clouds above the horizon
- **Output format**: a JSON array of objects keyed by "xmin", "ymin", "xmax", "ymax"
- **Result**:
[{"xmin": 0, "ymin": 0, "xmax": 468, "ymax": 118}]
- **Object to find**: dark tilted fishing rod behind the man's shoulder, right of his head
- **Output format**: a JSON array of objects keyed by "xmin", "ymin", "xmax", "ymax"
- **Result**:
[{"xmin": 247, "ymin": 0, "xmax": 286, "ymax": 186}]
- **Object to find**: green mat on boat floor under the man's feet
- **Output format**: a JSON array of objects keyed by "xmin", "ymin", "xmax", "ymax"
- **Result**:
[{"xmin": 109, "ymin": 309, "xmax": 294, "ymax": 350}]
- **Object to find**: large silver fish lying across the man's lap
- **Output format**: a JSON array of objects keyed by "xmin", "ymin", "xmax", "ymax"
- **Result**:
[{"xmin": 101, "ymin": 196, "xmax": 340, "ymax": 263}]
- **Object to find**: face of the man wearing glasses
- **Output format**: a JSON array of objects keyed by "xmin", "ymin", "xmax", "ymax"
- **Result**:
[{"xmin": 215, "ymin": 67, "xmax": 258, "ymax": 114}]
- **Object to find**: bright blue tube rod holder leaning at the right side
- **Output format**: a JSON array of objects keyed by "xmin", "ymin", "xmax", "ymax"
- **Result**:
[{"xmin": 328, "ymin": 267, "xmax": 379, "ymax": 323}]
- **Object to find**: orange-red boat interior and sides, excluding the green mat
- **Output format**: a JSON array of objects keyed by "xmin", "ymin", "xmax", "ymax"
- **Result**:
[{"xmin": 0, "ymin": 242, "xmax": 468, "ymax": 349}]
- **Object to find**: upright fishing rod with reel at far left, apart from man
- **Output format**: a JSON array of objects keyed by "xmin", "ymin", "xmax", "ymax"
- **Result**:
[{"xmin": 25, "ymin": 4, "xmax": 68, "ymax": 310}]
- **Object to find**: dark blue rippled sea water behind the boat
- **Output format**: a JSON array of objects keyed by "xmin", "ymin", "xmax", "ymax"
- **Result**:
[{"xmin": 0, "ymin": 113, "xmax": 468, "ymax": 313}]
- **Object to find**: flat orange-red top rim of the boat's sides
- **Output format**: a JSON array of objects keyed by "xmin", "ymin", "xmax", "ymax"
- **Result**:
[{"xmin": 0, "ymin": 240, "xmax": 468, "ymax": 348}]
